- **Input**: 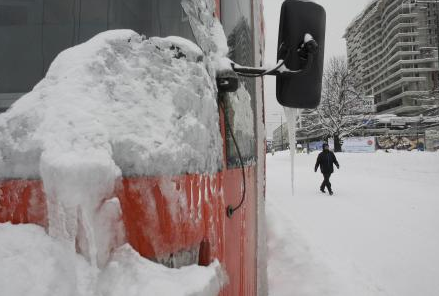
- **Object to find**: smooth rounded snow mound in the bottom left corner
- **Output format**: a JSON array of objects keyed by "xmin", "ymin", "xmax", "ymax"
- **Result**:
[{"xmin": 0, "ymin": 223, "xmax": 94, "ymax": 296}]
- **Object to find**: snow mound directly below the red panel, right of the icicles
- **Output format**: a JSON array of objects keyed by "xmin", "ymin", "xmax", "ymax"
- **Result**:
[{"xmin": 99, "ymin": 245, "xmax": 225, "ymax": 296}]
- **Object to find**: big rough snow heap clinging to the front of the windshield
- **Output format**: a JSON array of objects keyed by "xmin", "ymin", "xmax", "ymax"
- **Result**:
[{"xmin": 0, "ymin": 30, "xmax": 222, "ymax": 179}]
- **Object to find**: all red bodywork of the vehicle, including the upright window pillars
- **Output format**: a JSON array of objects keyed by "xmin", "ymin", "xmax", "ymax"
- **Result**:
[{"xmin": 0, "ymin": 0, "xmax": 265, "ymax": 295}]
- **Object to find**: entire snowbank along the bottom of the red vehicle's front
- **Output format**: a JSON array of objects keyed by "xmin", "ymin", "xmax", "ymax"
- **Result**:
[{"xmin": 0, "ymin": 223, "xmax": 224, "ymax": 295}]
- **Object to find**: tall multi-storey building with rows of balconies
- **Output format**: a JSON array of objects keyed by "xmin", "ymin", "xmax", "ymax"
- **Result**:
[{"xmin": 344, "ymin": 0, "xmax": 439, "ymax": 115}]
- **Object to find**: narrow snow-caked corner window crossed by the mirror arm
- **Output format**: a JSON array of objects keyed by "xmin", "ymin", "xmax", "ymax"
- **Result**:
[{"xmin": 221, "ymin": 0, "xmax": 256, "ymax": 168}]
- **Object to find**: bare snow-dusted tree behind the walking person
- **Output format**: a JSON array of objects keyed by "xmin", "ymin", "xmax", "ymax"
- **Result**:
[{"xmin": 316, "ymin": 57, "xmax": 371, "ymax": 152}]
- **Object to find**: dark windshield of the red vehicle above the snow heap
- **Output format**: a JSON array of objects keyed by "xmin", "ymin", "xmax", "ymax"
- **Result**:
[{"xmin": 0, "ymin": 0, "xmax": 195, "ymax": 112}]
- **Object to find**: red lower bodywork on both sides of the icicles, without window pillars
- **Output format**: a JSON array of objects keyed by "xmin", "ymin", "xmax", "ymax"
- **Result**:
[{"xmin": 0, "ymin": 167, "xmax": 257, "ymax": 295}]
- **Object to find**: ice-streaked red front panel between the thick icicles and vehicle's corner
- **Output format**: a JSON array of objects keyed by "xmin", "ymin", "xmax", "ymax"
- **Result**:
[{"xmin": 115, "ymin": 174, "xmax": 224, "ymax": 258}]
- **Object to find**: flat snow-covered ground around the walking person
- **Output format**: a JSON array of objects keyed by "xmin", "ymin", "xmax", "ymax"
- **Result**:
[{"xmin": 267, "ymin": 152, "xmax": 439, "ymax": 295}]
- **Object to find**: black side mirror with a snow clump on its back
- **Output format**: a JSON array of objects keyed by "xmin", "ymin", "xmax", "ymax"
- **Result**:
[{"xmin": 276, "ymin": 0, "xmax": 326, "ymax": 109}]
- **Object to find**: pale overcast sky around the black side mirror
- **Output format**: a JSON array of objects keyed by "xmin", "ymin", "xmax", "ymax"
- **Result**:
[{"xmin": 264, "ymin": 0, "xmax": 371, "ymax": 138}]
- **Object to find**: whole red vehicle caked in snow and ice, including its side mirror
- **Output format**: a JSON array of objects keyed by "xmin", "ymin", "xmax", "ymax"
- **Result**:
[{"xmin": 0, "ymin": 0, "xmax": 325, "ymax": 295}]
